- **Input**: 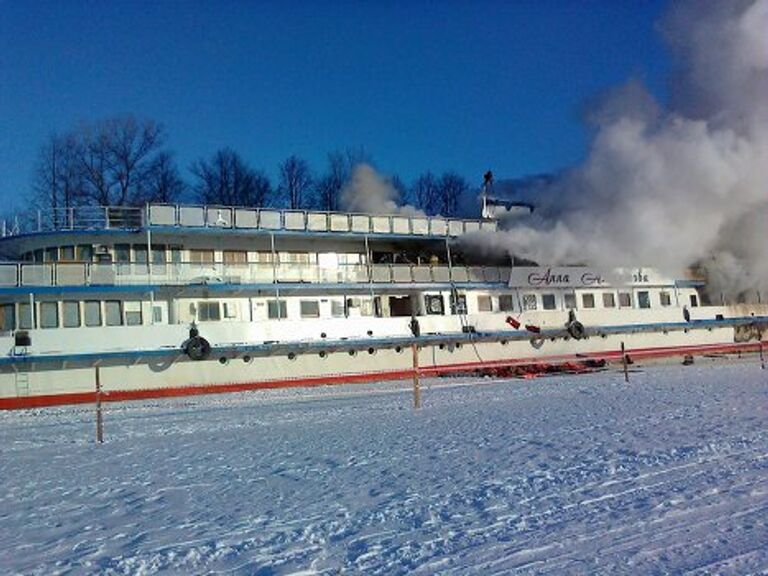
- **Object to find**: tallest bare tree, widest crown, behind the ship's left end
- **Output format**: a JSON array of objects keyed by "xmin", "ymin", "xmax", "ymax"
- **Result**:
[{"xmin": 76, "ymin": 116, "xmax": 164, "ymax": 206}]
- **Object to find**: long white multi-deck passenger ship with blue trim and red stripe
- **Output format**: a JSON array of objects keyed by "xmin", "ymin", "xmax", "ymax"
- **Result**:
[{"xmin": 0, "ymin": 204, "xmax": 768, "ymax": 409}]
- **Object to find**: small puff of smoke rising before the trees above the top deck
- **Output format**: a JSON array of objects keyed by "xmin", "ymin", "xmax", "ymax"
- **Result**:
[{"xmin": 341, "ymin": 164, "xmax": 424, "ymax": 216}]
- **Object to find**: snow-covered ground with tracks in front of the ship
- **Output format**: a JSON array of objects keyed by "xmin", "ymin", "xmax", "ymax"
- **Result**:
[{"xmin": 0, "ymin": 362, "xmax": 768, "ymax": 575}]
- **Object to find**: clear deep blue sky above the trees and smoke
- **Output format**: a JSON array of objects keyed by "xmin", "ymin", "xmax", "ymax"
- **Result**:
[{"xmin": 0, "ymin": 0, "xmax": 668, "ymax": 207}]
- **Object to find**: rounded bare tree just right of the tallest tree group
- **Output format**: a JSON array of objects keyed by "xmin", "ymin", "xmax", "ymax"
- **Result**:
[{"xmin": 192, "ymin": 148, "xmax": 272, "ymax": 206}]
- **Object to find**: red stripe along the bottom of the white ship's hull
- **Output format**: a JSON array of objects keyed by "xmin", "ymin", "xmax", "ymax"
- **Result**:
[{"xmin": 0, "ymin": 342, "xmax": 760, "ymax": 410}]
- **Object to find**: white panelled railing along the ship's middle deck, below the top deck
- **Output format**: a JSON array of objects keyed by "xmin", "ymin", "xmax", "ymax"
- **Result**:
[{"xmin": 0, "ymin": 262, "xmax": 509, "ymax": 287}]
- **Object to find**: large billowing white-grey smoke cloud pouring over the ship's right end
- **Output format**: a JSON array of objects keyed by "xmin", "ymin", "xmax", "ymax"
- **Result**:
[{"xmin": 474, "ymin": 0, "xmax": 768, "ymax": 302}]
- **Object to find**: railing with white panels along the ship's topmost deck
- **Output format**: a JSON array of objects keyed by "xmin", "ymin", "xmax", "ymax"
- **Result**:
[{"xmin": 2, "ymin": 204, "xmax": 496, "ymax": 237}]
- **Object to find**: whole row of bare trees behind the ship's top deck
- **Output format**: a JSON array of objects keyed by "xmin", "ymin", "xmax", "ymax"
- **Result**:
[{"xmin": 33, "ymin": 115, "xmax": 470, "ymax": 216}]
